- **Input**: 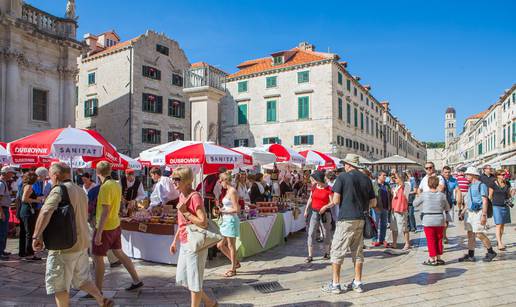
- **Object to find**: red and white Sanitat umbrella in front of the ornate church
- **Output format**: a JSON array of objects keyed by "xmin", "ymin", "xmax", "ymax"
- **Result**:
[{"xmin": 7, "ymin": 127, "xmax": 120, "ymax": 163}]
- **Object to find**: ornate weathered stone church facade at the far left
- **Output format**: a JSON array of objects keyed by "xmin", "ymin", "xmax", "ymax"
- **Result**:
[{"xmin": 0, "ymin": 0, "xmax": 83, "ymax": 142}]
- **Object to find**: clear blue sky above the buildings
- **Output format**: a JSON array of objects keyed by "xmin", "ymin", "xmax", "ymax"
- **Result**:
[{"xmin": 27, "ymin": 0, "xmax": 516, "ymax": 141}]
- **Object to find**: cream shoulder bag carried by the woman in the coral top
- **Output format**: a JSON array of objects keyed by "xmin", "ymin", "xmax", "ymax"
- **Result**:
[{"xmin": 181, "ymin": 192, "xmax": 222, "ymax": 253}]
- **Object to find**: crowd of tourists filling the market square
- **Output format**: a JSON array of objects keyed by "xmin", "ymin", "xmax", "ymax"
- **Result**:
[{"xmin": 0, "ymin": 154, "xmax": 514, "ymax": 306}]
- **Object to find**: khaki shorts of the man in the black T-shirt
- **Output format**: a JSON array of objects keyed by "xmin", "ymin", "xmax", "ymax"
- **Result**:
[{"xmin": 331, "ymin": 220, "xmax": 364, "ymax": 264}]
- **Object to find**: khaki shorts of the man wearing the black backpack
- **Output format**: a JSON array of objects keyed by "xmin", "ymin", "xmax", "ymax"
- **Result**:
[{"xmin": 45, "ymin": 249, "xmax": 91, "ymax": 294}]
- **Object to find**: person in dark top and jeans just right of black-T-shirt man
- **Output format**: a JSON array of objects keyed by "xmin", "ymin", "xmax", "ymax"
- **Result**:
[{"xmin": 373, "ymin": 171, "xmax": 392, "ymax": 248}]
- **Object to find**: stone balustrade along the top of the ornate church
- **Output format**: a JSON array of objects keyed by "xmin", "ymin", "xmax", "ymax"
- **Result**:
[{"xmin": 21, "ymin": 4, "xmax": 77, "ymax": 39}]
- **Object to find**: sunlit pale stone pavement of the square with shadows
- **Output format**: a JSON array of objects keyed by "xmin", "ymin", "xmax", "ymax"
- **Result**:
[{"xmin": 0, "ymin": 210, "xmax": 516, "ymax": 307}]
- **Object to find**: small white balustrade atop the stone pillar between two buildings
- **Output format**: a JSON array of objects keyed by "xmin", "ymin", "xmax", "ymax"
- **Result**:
[{"xmin": 184, "ymin": 65, "xmax": 226, "ymax": 92}]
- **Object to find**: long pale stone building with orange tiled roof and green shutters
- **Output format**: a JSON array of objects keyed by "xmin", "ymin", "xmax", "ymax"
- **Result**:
[{"xmin": 215, "ymin": 42, "xmax": 426, "ymax": 163}]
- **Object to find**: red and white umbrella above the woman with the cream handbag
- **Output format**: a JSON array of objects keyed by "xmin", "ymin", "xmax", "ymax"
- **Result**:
[{"xmin": 140, "ymin": 141, "xmax": 252, "ymax": 174}]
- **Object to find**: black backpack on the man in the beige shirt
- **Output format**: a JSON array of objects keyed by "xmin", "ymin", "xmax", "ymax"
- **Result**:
[{"xmin": 43, "ymin": 184, "xmax": 77, "ymax": 250}]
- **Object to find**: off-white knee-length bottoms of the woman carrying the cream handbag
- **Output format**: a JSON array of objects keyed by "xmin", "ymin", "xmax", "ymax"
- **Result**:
[{"xmin": 176, "ymin": 245, "xmax": 208, "ymax": 292}]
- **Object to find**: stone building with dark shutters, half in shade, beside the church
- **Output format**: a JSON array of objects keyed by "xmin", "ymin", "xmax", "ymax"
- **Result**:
[{"xmin": 76, "ymin": 31, "xmax": 191, "ymax": 156}]
